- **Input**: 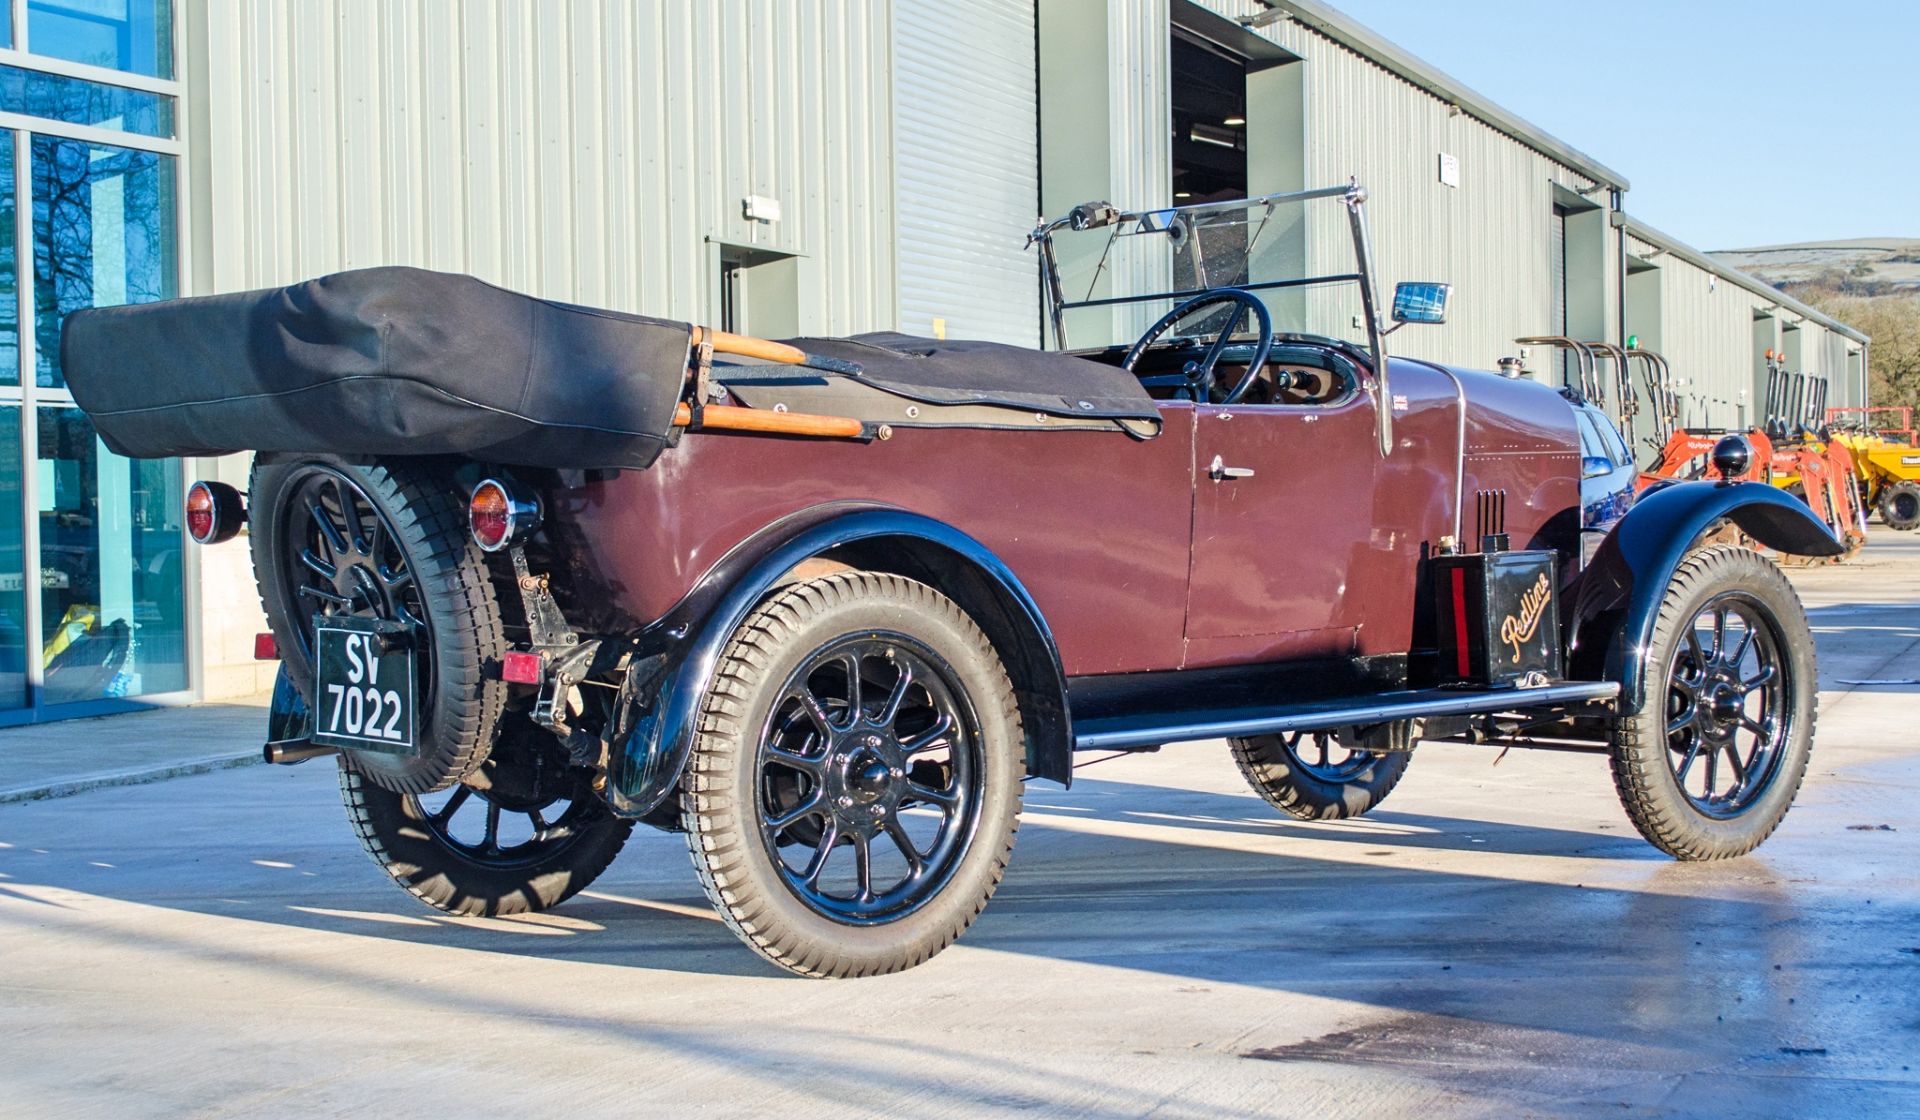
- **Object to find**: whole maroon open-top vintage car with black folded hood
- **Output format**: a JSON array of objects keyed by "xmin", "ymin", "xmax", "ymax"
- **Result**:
[{"xmin": 63, "ymin": 186, "xmax": 1839, "ymax": 976}]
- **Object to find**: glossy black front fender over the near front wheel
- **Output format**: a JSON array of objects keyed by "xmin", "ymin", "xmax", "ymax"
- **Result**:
[{"xmin": 1567, "ymin": 482, "xmax": 1847, "ymax": 713}]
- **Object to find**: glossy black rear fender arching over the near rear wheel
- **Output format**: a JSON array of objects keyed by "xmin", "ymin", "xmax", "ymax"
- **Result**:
[{"xmin": 607, "ymin": 503, "xmax": 1073, "ymax": 816}]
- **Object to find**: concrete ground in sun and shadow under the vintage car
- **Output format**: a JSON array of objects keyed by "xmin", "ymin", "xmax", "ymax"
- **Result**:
[{"xmin": 0, "ymin": 530, "xmax": 1920, "ymax": 1120}]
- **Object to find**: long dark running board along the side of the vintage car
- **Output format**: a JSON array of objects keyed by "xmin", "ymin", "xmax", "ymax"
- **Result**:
[{"xmin": 1073, "ymin": 680, "xmax": 1620, "ymax": 751}]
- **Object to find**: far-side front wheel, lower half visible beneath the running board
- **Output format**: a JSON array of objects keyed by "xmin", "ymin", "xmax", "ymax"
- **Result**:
[{"xmin": 1227, "ymin": 722, "xmax": 1413, "ymax": 820}]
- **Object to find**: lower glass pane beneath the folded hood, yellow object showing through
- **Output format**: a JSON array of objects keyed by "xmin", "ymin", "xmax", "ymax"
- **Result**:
[{"xmin": 36, "ymin": 407, "xmax": 186, "ymax": 703}]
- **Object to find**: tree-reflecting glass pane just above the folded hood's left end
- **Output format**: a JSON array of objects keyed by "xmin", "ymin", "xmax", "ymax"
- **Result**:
[{"xmin": 33, "ymin": 134, "xmax": 179, "ymax": 388}]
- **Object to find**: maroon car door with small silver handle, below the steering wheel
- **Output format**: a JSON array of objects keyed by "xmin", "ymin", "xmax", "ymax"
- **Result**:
[{"xmin": 1187, "ymin": 392, "xmax": 1380, "ymax": 667}]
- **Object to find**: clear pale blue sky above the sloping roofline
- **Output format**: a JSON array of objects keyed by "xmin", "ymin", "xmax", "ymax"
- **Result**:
[{"xmin": 1331, "ymin": 0, "xmax": 1920, "ymax": 250}]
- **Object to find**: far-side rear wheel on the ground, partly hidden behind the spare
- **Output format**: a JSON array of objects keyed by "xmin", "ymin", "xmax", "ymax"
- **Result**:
[{"xmin": 340, "ymin": 728, "xmax": 634, "ymax": 916}]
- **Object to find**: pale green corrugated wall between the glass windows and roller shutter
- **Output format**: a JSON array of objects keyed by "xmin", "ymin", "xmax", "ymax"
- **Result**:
[{"xmin": 184, "ymin": 0, "xmax": 895, "ymax": 332}]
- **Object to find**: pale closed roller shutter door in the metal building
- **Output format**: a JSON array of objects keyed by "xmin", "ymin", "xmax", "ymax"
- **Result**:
[{"xmin": 893, "ymin": 0, "xmax": 1041, "ymax": 346}]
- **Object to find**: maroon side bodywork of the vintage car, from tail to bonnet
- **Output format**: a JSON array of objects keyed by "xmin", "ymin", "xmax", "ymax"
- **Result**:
[{"xmin": 549, "ymin": 361, "xmax": 1578, "ymax": 676}]
